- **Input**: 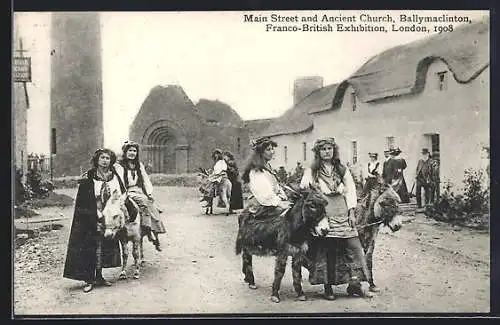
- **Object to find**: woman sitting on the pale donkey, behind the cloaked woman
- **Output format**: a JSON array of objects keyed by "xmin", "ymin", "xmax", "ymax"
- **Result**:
[{"xmin": 114, "ymin": 141, "xmax": 166, "ymax": 251}]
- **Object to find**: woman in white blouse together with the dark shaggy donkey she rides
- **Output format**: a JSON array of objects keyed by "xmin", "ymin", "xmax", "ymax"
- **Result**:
[{"xmin": 236, "ymin": 138, "xmax": 327, "ymax": 303}]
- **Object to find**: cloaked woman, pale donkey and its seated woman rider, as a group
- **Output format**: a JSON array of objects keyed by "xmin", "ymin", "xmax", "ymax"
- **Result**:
[{"xmin": 63, "ymin": 141, "xmax": 166, "ymax": 292}]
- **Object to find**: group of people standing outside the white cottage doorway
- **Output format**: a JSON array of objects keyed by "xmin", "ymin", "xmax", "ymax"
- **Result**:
[{"xmin": 363, "ymin": 148, "xmax": 440, "ymax": 208}]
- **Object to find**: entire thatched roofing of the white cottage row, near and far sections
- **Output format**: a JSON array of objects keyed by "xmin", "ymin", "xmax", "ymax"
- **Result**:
[{"xmin": 261, "ymin": 17, "xmax": 489, "ymax": 136}]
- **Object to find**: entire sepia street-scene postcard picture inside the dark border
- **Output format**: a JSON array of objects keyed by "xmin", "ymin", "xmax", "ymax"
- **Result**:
[{"xmin": 11, "ymin": 10, "xmax": 491, "ymax": 319}]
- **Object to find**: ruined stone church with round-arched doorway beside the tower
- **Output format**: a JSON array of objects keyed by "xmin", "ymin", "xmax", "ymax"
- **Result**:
[{"xmin": 129, "ymin": 85, "xmax": 270, "ymax": 174}]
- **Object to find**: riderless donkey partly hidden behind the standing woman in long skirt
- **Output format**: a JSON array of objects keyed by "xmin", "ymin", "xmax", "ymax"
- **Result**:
[{"xmin": 355, "ymin": 184, "xmax": 402, "ymax": 292}]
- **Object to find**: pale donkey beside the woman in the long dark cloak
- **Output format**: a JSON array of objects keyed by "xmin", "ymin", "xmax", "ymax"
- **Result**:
[{"xmin": 102, "ymin": 190, "xmax": 147, "ymax": 279}]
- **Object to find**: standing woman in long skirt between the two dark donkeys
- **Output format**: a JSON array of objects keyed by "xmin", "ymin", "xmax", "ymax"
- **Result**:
[{"xmin": 300, "ymin": 138, "xmax": 373, "ymax": 300}]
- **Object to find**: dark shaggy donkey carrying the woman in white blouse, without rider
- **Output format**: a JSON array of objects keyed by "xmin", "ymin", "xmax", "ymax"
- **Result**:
[{"xmin": 236, "ymin": 187, "xmax": 328, "ymax": 302}]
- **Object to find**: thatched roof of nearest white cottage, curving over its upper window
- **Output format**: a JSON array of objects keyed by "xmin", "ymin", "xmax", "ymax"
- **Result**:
[{"xmin": 347, "ymin": 17, "xmax": 490, "ymax": 102}]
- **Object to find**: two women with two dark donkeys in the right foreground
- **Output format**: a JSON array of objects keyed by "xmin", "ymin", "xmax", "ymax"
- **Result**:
[{"xmin": 236, "ymin": 137, "xmax": 401, "ymax": 302}]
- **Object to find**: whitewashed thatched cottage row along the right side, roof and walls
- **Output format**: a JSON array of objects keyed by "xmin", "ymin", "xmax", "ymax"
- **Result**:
[{"xmin": 261, "ymin": 18, "xmax": 490, "ymax": 187}]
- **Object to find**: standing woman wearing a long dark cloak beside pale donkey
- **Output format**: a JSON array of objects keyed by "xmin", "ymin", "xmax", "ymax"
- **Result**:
[{"xmin": 63, "ymin": 149, "xmax": 137, "ymax": 292}]
